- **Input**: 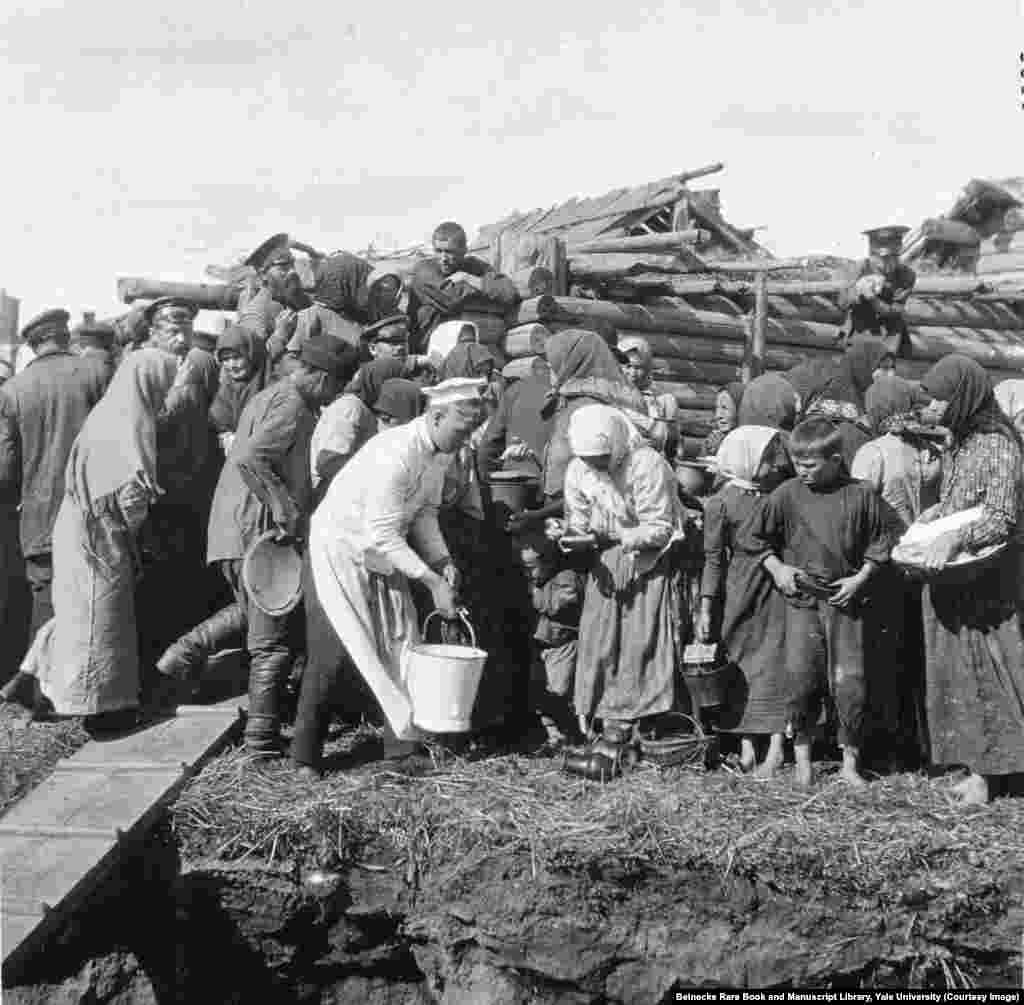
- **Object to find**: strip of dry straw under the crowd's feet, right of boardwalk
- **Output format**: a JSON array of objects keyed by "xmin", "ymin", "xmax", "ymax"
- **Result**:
[{"xmin": 173, "ymin": 727, "xmax": 1024, "ymax": 899}]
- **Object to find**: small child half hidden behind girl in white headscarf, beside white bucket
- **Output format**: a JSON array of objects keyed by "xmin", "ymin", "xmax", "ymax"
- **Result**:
[{"xmin": 519, "ymin": 534, "xmax": 584, "ymax": 747}]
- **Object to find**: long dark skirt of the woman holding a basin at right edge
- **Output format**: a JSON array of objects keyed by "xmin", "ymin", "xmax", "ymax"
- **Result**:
[{"xmin": 924, "ymin": 548, "xmax": 1024, "ymax": 776}]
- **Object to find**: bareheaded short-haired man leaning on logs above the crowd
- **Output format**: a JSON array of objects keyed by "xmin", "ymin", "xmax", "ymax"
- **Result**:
[{"xmin": 409, "ymin": 221, "xmax": 519, "ymax": 352}]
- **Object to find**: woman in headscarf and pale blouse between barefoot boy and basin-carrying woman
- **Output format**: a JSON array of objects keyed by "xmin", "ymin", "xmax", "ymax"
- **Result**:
[{"xmin": 850, "ymin": 375, "xmax": 941, "ymax": 768}]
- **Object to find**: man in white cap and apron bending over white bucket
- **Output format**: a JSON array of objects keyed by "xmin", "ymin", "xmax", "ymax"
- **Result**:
[{"xmin": 292, "ymin": 378, "xmax": 486, "ymax": 777}]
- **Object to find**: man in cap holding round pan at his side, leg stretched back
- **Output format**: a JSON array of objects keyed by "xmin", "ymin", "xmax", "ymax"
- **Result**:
[{"xmin": 151, "ymin": 336, "xmax": 358, "ymax": 756}]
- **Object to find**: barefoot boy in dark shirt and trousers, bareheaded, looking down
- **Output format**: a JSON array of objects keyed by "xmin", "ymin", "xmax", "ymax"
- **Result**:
[{"xmin": 740, "ymin": 418, "xmax": 891, "ymax": 785}]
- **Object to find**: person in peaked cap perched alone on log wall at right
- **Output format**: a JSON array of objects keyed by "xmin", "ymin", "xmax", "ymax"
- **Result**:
[{"xmin": 840, "ymin": 226, "xmax": 918, "ymax": 358}]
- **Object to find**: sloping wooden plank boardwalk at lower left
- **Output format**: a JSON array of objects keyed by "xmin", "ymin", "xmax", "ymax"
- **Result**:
[{"xmin": 0, "ymin": 698, "xmax": 245, "ymax": 985}]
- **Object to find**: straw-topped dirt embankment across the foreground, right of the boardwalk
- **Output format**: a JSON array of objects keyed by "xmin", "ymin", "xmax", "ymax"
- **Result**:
[{"xmin": 5, "ymin": 741, "xmax": 1024, "ymax": 1005}]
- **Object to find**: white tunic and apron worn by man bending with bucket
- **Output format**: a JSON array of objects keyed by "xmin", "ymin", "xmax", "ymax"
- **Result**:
[{"xmin": 309, "ymin": 417, "xmax": 452, "ymax": 738}]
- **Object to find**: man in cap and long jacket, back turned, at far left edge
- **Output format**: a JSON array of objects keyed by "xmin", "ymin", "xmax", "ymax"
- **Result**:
[{"xmin": 0, "ymin": 310, "xmax": 110, "ymax": 684}]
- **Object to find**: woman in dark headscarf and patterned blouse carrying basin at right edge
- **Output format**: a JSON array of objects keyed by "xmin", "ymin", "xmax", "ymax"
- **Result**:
[{"xmin": 921, "ymin": 354, "xmax": 1024, "ymax": 803}]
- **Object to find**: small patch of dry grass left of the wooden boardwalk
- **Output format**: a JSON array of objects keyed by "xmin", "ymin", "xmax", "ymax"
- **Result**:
[{"xmin": 0, "ymin": 704, "xmax": 89, "ymax": 815}]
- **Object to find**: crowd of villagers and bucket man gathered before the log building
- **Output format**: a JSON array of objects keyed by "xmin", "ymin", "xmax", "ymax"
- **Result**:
[{"xmin": 0, "ymin": 224, "xmax": 1024, "ymax": 803}]
